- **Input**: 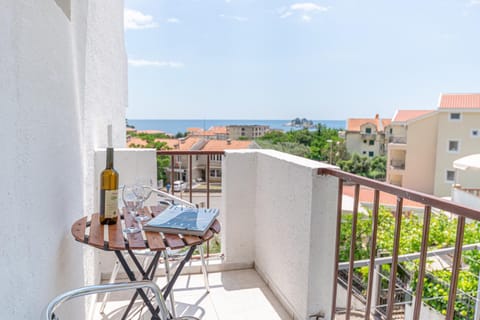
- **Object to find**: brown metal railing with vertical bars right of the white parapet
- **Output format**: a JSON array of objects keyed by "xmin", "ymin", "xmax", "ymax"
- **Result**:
[{"xmin": 318, "ymin": 168, "xmax": 480, "ymax": 320}]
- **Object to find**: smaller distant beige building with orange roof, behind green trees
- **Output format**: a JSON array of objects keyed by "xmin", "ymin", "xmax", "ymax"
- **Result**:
[{"xmin": 345, "ymin": 114, "xmax": 390, "ymax": 157}]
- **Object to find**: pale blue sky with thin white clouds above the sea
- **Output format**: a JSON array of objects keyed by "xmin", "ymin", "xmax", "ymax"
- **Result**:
[{"xmin": 125, "ymin": 0, "xmax": 480, "ymax": 120}]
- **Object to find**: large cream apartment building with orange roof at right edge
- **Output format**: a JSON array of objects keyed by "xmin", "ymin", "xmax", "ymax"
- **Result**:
[{"xmin": 387, "ymin": 94, "xmax": 480, "ymax": 196}]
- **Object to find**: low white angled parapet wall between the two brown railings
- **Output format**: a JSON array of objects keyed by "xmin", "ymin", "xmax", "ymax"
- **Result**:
[{"xmin": 222, "ymin": 150, "xmax": 338, "ymax": 319}]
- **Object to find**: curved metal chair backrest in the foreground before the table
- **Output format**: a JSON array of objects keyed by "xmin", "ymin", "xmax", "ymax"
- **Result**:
[{"xmin": 40, "ymin": 281, "xmax": 169, "ymax": 320}]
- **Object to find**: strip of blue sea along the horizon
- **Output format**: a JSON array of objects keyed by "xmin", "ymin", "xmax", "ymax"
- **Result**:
[{"xmin": 128, "ymin": 119, "xmax": 345, "ymax": 135}]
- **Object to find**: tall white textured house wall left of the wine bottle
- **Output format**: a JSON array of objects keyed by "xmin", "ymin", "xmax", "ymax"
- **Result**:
[{"xmin": 0, "ymin": 0, "xmax": 127, "ymax": 320}]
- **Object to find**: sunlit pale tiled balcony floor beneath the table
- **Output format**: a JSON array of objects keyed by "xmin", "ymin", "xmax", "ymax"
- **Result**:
[{"xmin": 93, "ymin": 269, "xmax": 292, "ymax": 320}]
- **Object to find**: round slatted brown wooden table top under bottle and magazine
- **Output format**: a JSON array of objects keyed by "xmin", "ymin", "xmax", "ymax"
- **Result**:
[{"xmin": 72, "ymin": 205, "xmax": 221, "ymax": 251}]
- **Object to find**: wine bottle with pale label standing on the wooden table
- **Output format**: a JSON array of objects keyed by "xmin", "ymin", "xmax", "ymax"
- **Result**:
[{"xmin": 100, "ymin": 125, "xmax": 118, "ymax": 224}]
